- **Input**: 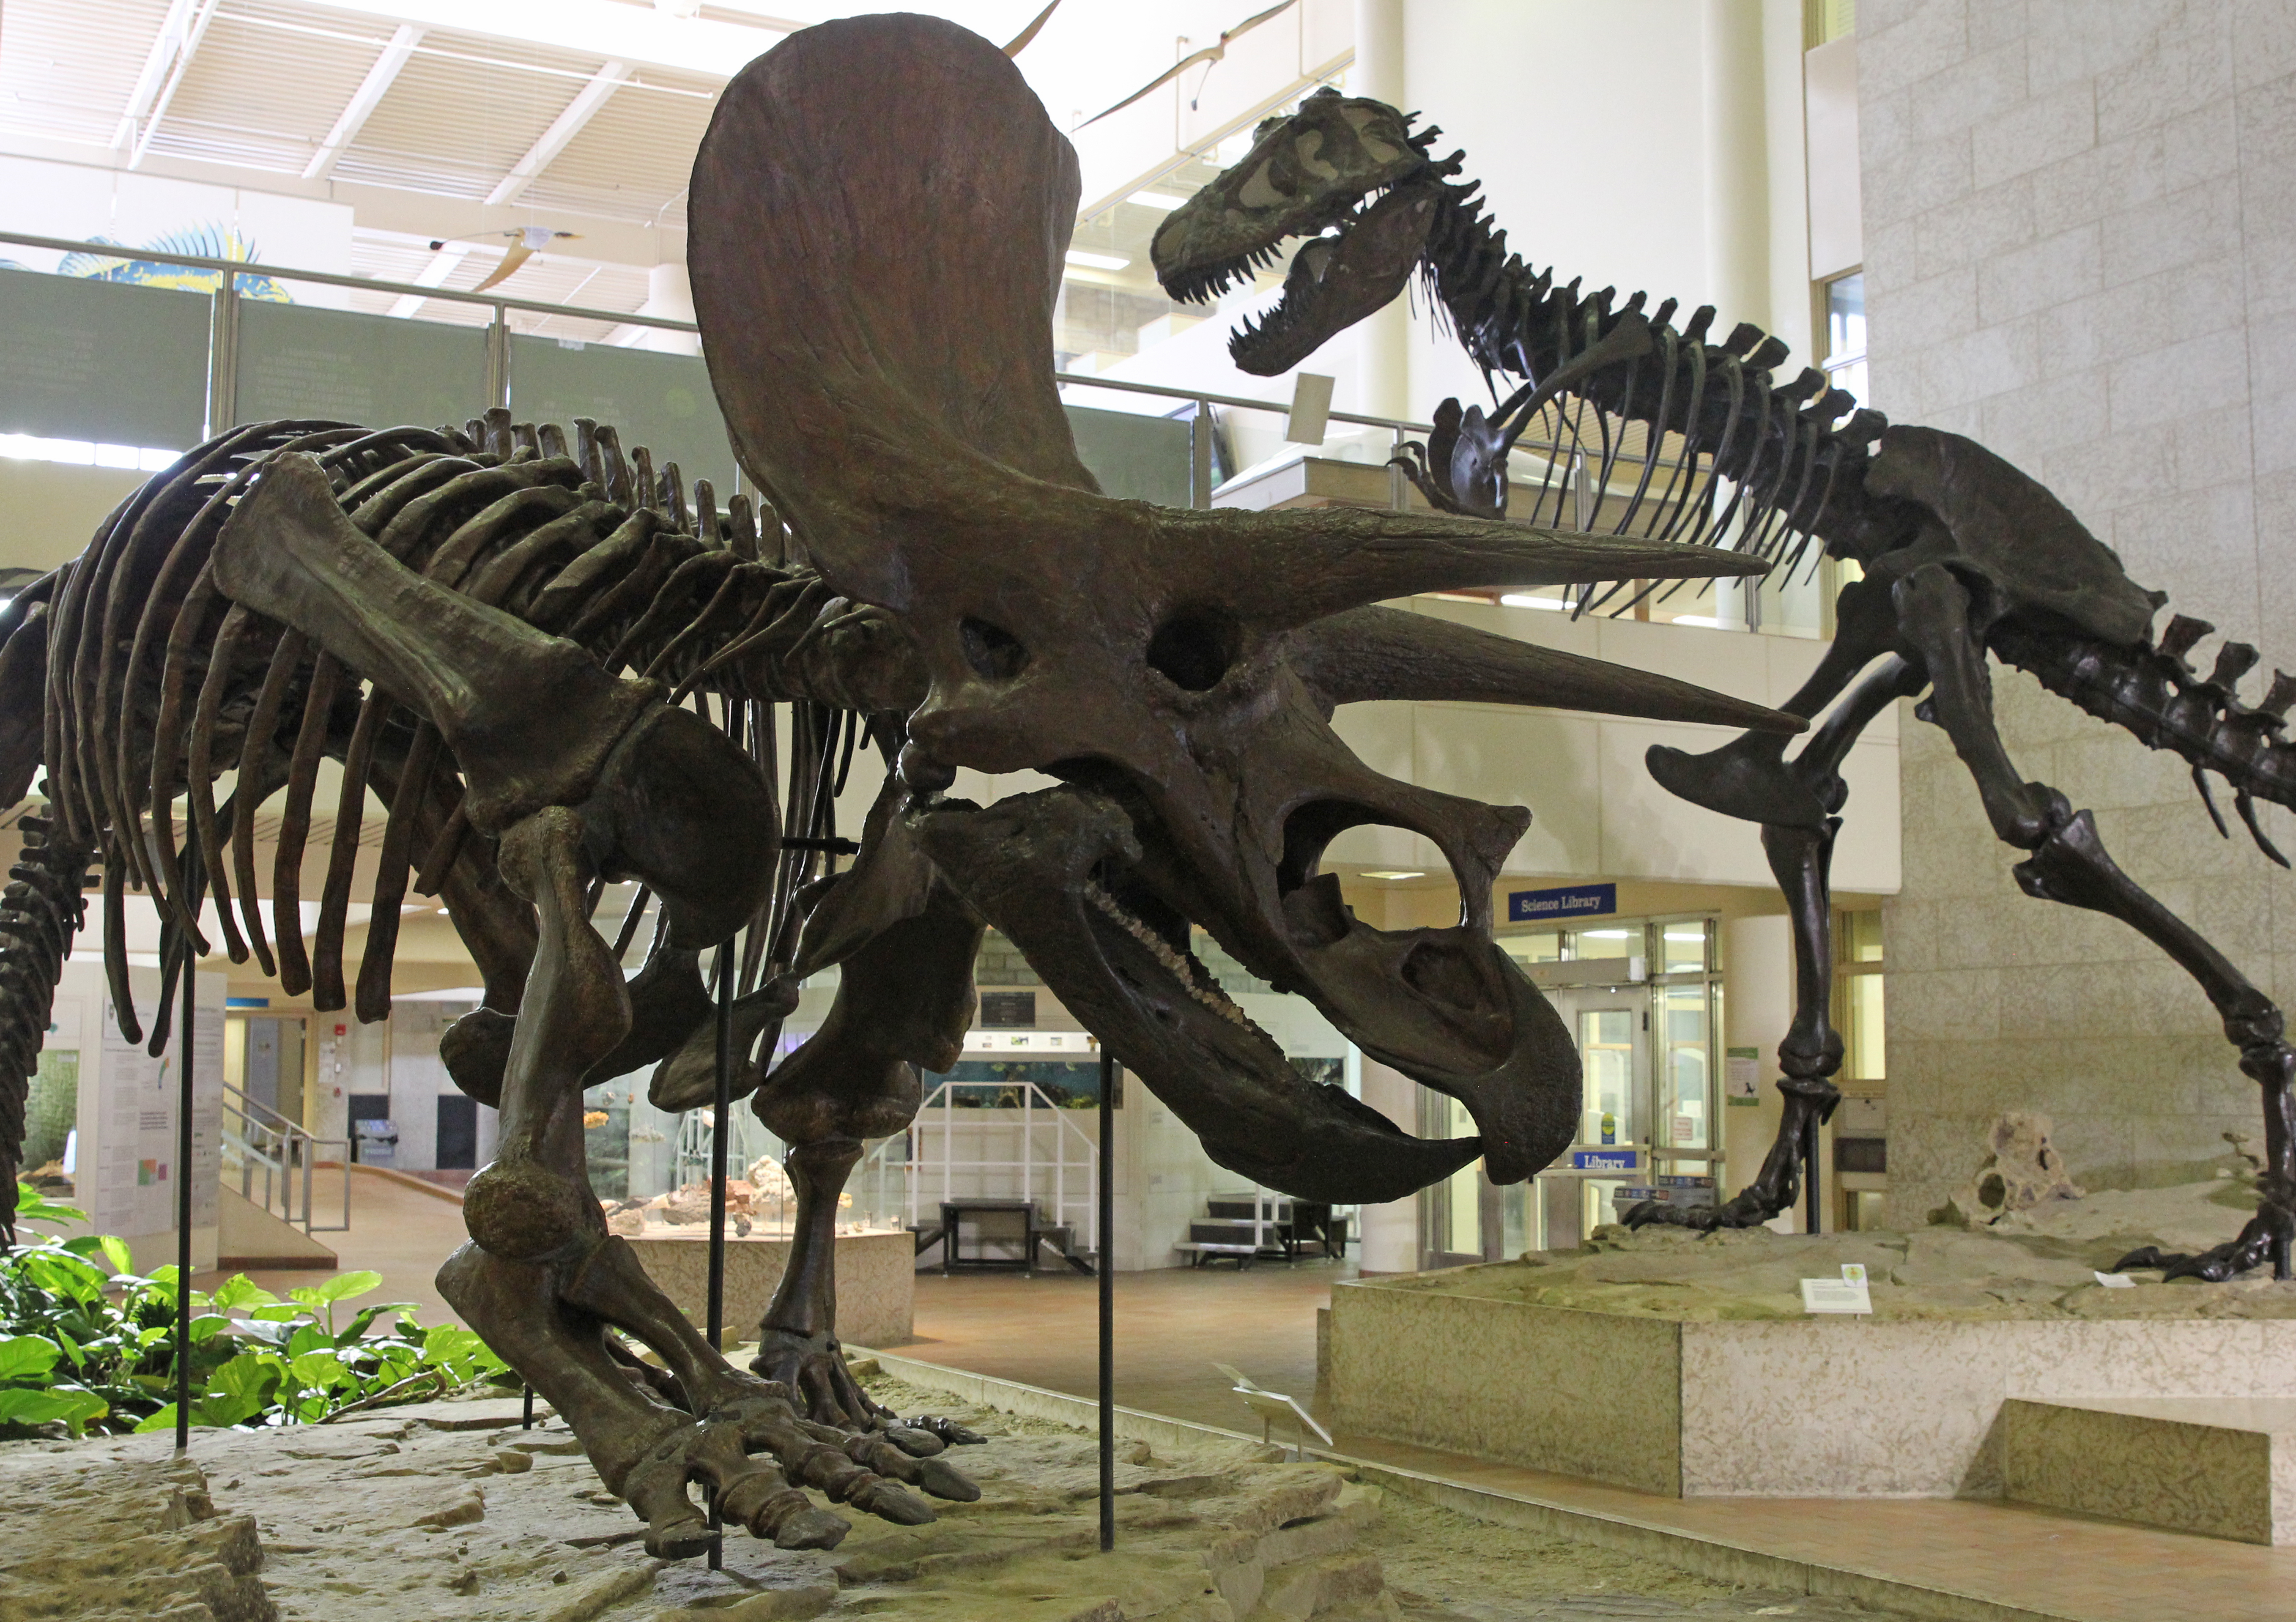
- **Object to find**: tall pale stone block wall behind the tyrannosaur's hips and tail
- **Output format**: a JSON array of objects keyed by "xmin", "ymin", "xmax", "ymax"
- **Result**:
[{"xmin": 1858, "ymin": 0, "xmax": 2296, "ymax": 1222}]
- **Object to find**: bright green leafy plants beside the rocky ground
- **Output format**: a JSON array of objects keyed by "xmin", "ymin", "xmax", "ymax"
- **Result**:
[{"xmin": 0, "ymin": 1183, "xmax": 514, "ymax": 1436}]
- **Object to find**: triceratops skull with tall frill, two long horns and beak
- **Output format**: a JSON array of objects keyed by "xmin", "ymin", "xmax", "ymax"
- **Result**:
[{"xmin": 691, "ymin": 16, "xmax": 1791, "ymax": 1202}]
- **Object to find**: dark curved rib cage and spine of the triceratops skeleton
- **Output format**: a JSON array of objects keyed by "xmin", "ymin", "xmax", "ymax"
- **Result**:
[{"xmin": 0, "ymin": 411, "xmax": 916, "ymax": 1084}]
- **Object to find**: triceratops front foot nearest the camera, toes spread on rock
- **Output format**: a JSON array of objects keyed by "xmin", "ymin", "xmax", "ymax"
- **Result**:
[{"xmin": 620, "ymin": 1381, "xmax": 981, "ymax": 1560}]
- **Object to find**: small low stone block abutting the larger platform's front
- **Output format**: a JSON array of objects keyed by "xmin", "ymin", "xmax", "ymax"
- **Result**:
[{"xmin": 2002, "ymin": 1397, "xmax": 2296, "ymax": 1544}]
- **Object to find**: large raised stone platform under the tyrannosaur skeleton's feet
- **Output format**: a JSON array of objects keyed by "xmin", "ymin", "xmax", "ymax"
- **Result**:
[{"xmin": 1327, "ymin": 1186, "xmax": 2296, "ymax": 1488}]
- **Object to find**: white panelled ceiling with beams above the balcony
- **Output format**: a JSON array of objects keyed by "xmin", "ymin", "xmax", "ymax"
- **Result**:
[{"xmin": 0, "ymin": 0, "xmax": 1336, "ymax": 338}]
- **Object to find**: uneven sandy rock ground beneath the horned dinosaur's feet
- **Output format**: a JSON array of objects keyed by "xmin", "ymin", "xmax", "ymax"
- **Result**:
[{"xmin": 0, "ymin": 1381, "xmax": 1919, "ymax": 1622}]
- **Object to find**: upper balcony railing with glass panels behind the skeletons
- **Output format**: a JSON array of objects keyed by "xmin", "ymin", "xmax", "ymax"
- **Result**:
[{"xmin": 0, "ymin": 232, "xmax": 1835, "ymax": 636}]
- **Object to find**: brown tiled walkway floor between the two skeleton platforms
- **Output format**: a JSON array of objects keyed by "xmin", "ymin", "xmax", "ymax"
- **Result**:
[{"xmin": 900, "ymin": 1263, "xmax": 2296, "ymax": 1622}]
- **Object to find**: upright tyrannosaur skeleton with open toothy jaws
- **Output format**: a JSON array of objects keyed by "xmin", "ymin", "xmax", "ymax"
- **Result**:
[{"xmin": 1153, "ymin": 90, "xmax": 2296, "ymax": 1280}]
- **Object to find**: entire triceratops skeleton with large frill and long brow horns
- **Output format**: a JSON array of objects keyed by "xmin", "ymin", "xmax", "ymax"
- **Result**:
[{"xmin": 0, "ymin": 18, "xmax": 1798, "ymax": 1555}]
